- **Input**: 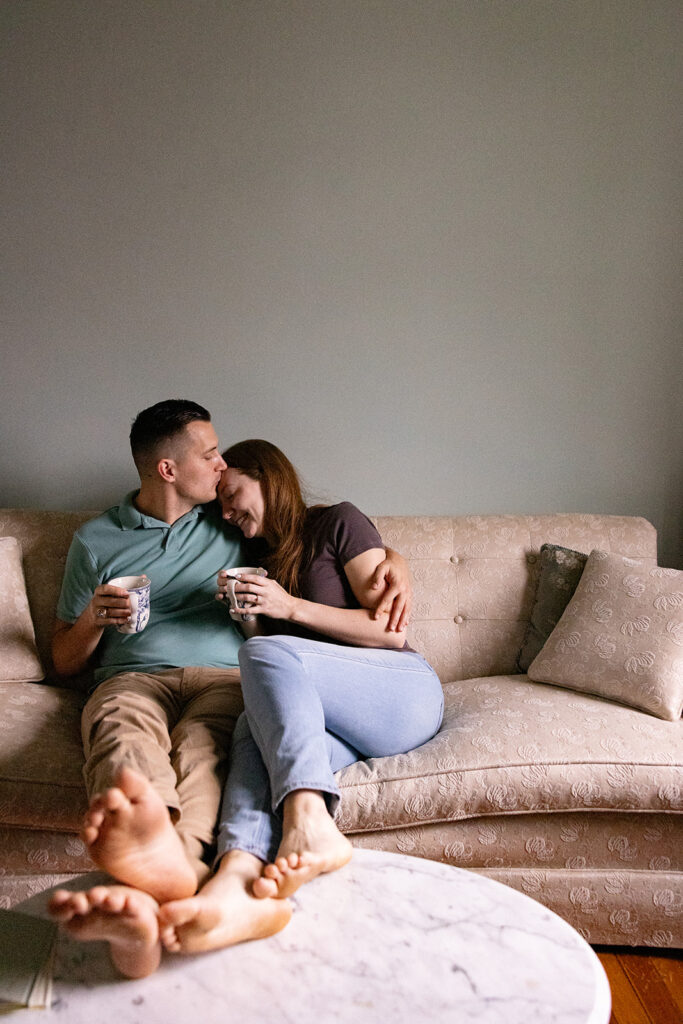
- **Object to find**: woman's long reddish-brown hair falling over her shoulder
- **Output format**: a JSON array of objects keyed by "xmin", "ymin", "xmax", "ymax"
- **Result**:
[{"xmin": 223, "ymin": 439, "xmax": 306, "ymax": 597}]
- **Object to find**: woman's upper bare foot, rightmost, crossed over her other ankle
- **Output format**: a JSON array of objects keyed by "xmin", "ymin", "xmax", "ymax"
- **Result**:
[{"xmin": 253, "ymin": 790, "xmax": 353, "ymax": 899}]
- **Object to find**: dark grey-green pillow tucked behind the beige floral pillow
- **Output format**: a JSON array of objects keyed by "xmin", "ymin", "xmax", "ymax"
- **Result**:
[{"xmin": 516, "ymin": 544, "xmax": 588, "ymax": 672}]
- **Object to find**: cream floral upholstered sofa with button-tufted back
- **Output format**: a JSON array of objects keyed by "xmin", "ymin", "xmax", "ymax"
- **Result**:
[{"xmin": 0, "ymin": 509, "xmax": 683, "ymax": 947}]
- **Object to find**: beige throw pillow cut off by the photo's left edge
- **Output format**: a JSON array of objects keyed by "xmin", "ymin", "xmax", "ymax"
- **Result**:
[{"xmin": 0, "ymin": 537, "xmax": 45, "ymax": 683}]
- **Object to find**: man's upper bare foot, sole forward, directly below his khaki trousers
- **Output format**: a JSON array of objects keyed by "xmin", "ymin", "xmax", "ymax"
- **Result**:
[{"xmin": 81, "ymin": 768, "xmax": 197, "ymax": 903}]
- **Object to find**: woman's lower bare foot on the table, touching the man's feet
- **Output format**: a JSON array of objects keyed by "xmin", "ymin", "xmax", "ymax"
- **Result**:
[{"xmin": 159, "ymin": 850, "xmax": 292, "ymax": 953}]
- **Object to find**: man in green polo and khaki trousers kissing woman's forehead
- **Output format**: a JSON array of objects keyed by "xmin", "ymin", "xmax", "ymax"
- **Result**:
[{"xmin": 52, "ymin": 399, "xmax": 411, "ymax": 975}]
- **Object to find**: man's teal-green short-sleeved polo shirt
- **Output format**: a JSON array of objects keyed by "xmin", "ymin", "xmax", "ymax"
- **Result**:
[{"xmin": 57, "ymin": 492, "xmax": 244, "ymax": 683}]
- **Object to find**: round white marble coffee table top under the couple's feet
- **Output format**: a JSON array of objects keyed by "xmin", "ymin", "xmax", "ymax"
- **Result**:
[{"xmin": 9, "ymin": 850, "xmax": 610, "ymax": 1024}]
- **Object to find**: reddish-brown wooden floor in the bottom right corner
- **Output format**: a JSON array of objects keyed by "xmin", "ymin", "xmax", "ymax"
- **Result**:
[{"xmin": 594, "ymin": 946, "xmax": 683, "ymax": 1024}]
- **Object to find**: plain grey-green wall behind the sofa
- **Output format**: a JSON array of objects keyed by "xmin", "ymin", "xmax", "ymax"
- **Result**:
[{"xmin": 0, "ymin": 0, "xmax": 683, "ymax": 565}]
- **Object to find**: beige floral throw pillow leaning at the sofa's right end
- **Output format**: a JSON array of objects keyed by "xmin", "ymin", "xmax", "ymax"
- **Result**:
[{"xmin": 528, "ymin": 551, "xmax": 683, "ymax": 722}]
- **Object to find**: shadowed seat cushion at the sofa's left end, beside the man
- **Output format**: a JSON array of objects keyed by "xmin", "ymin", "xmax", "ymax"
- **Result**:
[{"xmin": 0, "ymin": 683, "xmax": 87, "ymax": 833}]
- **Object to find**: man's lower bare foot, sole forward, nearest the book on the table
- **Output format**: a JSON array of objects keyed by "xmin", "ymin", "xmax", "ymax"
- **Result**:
[{"xmin": 48, "ymin": 886, "xmax": 161, "ymax": 978}]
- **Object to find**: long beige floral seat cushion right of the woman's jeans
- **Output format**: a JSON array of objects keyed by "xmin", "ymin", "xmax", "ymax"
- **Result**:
[{"xmin": 339, "ymin": 676, "xmax": 683, "ymax": 833}]
